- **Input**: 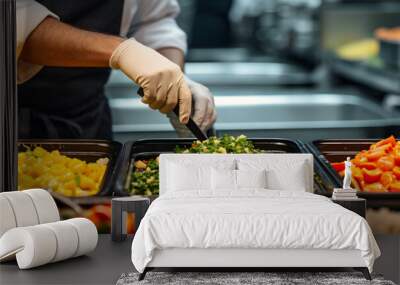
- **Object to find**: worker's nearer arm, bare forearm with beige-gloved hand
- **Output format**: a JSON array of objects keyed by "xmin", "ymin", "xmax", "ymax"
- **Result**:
[{"xmin": 20, "ymin": 18, "xmax": 192, "ymax": 123}]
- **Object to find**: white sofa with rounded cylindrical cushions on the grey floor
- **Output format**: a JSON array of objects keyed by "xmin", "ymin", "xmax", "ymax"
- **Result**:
[{"xmin": 0, "ymin": 189, "xmax": 98, "ymax": 269}]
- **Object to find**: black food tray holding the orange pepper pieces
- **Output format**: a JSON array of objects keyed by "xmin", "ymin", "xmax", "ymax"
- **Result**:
[{"xmin": 307, "ymin": 139, "xmax": 400, "ymax": 209}]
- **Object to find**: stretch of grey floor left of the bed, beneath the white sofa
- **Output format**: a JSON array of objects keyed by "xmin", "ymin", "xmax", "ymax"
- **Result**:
[{"xmin": 0, "ymin": 235, "xmax": 134, "ymax": 285}]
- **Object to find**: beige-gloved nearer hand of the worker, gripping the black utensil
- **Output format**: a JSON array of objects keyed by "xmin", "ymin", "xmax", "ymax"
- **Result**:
[{"xmin": 110, "ymin": 39, "xmax": 192, "ymax": 124}]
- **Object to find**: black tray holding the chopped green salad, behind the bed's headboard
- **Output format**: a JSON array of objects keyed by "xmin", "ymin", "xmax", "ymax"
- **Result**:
[{"xmin": 114, "ymin": 138, "xmax": 334, "ymax": 198}]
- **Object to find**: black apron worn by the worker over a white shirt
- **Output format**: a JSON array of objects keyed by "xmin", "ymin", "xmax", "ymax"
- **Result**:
[{"xmin": 18, "ymin": 0, "xmax": 124, "ymax": 139}]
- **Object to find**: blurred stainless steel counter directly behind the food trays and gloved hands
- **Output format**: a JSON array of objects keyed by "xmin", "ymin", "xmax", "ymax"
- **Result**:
[{"xmin": 107, "ymin": 70, "xmax": 400, "ymax": 141}]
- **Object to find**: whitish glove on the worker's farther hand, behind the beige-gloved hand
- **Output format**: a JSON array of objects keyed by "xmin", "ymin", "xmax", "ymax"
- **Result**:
[{"xmin": 167, "ymin": 76, "xmax": 217, "ymax": 138}]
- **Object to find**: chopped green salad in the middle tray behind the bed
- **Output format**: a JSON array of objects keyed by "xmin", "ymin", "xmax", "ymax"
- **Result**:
[{"xmin": 128, "ymin": 135, "xmax": 261, "ymax": 196}]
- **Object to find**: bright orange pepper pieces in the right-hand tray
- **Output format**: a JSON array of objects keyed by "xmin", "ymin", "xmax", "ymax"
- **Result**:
[{"xmin": 331, "ymin": 136, "xmax": 400, "ymax": 193}]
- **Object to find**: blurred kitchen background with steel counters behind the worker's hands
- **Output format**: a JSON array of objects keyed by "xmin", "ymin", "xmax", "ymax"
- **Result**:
[{"xmin": 107, "ymin": 0, "xmax": 400, "ymax": 142}]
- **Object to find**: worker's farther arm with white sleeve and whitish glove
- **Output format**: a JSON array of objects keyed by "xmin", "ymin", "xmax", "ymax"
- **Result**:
[{"xmin": 127, "ymin": 0, "xmax": 217, "ymax": 133}]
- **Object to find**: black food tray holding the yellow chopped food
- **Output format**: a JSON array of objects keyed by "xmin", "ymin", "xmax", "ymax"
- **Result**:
[{"xmin": 18, "ymin": 139, "xmax": 122, "ymax": 196}]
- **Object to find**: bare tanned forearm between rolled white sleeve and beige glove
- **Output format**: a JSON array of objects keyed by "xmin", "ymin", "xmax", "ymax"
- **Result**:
[{"xmin": 20, "ymin": 17, "xmax": 124, "ymax": 67}]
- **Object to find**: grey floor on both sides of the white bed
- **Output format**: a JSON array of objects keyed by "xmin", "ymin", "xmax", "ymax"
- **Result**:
[{"xmin": 0, "ymin": 235, "xmax": 400, "ymax": 285}]
